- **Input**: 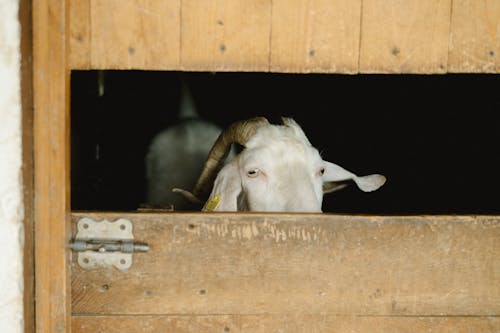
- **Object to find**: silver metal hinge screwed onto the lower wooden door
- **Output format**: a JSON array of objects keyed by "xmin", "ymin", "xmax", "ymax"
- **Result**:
[{"xmin": 69, "ymin": 217, "xmax": 149, "ymax": 270}]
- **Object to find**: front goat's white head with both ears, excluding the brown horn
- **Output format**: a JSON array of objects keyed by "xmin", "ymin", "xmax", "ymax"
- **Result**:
[{"xmin": 205, "ymin": 118, "xmax": 385, "ymax": 212}]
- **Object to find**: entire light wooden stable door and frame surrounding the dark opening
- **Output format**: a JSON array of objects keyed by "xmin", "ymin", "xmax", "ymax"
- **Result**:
[{"xmin": 33, "ymin": 0, "xmax": 500, "ymax": 333}]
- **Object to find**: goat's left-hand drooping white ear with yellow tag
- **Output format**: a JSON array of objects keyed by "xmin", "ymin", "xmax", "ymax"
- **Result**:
[{"xmin": 203, "ymin": 162, "xmax": 241, "ymax": 212}]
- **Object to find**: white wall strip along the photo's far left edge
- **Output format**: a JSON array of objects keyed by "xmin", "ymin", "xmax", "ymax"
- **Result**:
[{"xmin": 0, "ymin": 0, "xmax": 24, "ymax": 333}]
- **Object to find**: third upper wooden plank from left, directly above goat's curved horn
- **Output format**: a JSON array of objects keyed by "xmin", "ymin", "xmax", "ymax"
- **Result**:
[{"xmin": 181, "ymin": 0, "xmax": 271, "ymax": 71}]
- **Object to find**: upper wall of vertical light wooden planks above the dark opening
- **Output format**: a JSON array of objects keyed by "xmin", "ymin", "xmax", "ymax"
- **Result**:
[{"xmin": 69, "ymin": 0, "xmax": 500, "ymax": 73}]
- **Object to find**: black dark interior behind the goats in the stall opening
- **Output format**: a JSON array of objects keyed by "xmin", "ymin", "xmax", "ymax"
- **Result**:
[{"xmin": 71, "ymin": 71, "xmax": 500, "ymax": 214}]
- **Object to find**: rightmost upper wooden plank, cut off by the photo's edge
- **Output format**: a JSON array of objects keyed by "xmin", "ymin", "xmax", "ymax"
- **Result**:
[{"xmin": 448, "ymin": 0, "xmax": 500, "ymax": 73}]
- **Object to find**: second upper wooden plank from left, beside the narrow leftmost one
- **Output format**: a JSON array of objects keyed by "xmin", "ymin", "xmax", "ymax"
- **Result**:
[{"xmin": 90, "ymin": 0, "xmax": 180, "ymax": 70}]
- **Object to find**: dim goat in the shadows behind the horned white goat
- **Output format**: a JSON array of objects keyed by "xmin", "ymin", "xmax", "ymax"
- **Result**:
[{"xmin": 145, "ymin": 79, "xmax": 222, "ymax": 210}]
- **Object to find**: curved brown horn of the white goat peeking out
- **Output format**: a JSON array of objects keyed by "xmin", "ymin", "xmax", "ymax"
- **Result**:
[{"xmin": 174, "ymin": 117, "xmax": 269, "ymax": 203}]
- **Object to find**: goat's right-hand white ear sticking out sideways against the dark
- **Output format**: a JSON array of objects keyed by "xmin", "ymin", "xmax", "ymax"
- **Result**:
[{"xmin": 323, "ymin": 161, "xmax": 386, "ymax": 193}]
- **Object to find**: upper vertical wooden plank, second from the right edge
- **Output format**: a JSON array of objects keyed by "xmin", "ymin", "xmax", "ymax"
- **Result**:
[{"xmin": 360, "ymin": 0, "xmax": 451, "ymax": 73}]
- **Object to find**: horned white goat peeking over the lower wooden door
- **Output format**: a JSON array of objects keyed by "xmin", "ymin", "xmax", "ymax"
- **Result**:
[{"xmin": 173, "ymin": 117, "xmax": 386, "ymax": 212}]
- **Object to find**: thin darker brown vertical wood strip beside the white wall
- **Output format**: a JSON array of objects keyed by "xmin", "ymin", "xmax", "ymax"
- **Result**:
[{"xmin": 19, "ymin": 0, "xmax": 35, "ymax": 333}]
